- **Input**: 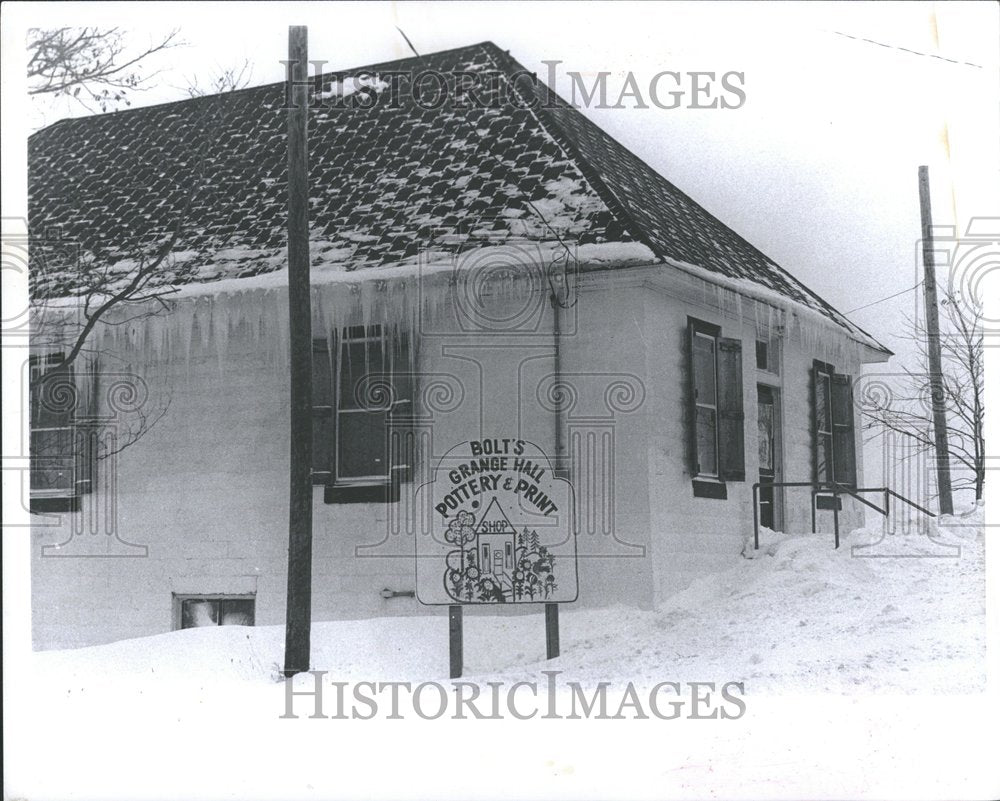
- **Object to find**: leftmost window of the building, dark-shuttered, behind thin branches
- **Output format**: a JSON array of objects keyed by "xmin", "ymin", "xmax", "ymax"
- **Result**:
[{"xmin": 28, "ymin": 353, "xmax": 95, "ymax": 512}]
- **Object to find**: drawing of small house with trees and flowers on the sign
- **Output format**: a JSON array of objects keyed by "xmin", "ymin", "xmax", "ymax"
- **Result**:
[{"xmin": 444, "ymin": 498, "xmax": 558, "ymax": 603}]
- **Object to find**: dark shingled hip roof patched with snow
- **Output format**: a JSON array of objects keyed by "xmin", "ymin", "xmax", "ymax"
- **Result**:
[{"xmin": 28, "ymin": 42, "xmax": 884, "ymax": 348}]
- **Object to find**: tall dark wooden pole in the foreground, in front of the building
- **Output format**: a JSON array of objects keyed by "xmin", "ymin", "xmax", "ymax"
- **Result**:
[{"xmin": 285, "ymin": 25, "xmax": 313, "ymax": 676}]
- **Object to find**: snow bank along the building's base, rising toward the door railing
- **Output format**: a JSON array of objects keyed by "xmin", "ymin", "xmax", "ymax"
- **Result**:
[{"xmin": 29, "ymin": 506, "xmax": 985, "ymax": 694}]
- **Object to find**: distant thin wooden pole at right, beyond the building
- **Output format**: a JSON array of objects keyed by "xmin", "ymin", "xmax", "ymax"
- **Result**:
[{"xmin": 917, "ymin": 167, "xmax": 954, "ymax": 515}]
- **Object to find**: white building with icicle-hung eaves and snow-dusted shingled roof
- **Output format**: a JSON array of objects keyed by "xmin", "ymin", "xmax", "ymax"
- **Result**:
[{"xmin": 29, "ymin": 43, "xmax": 890, "ymax": 648}]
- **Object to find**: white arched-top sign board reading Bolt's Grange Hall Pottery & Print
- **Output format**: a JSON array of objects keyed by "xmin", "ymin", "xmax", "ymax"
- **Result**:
[{"xmin": 416, "ymin": 438, "xmax": 577, "ymax": 604}]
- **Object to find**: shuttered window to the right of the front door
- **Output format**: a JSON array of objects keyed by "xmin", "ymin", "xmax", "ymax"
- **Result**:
[{"xmin": 812, "ymin": 361, "xmax": 857, "ymax": 487}]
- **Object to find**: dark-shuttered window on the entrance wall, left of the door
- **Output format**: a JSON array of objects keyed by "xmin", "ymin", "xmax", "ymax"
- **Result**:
[{"xmin": 688, "ymin": 318, "xmax": 745, "ymax": 497}]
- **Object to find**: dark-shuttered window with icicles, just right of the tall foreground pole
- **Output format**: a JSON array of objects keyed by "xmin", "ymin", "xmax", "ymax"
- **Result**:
[{"xmin": 313, "ymin": 325, "xmax": 412, "ymax": 503}]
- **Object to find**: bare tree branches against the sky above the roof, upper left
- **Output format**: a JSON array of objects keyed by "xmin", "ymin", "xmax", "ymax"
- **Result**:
[{"xmin": 28, "ymin": 27, "xmax": 181, "ymax": 111}]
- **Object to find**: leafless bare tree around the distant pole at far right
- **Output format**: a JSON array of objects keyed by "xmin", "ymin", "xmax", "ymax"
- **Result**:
[{"xmin": 861, "ymin": 290, "xmax": 986, "ymax": 501}]
